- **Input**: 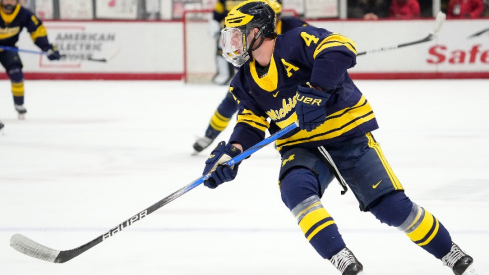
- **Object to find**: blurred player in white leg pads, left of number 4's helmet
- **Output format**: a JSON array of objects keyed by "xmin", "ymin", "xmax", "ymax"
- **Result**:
[{"xmin": 209, "ymin": 0, "xmax": 243, "ymax": 85}]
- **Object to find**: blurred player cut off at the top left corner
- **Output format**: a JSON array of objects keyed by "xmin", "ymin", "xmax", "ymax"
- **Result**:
[{"xmin": 0, "ymin": 0, "xmax": 60, "ymax": 119}]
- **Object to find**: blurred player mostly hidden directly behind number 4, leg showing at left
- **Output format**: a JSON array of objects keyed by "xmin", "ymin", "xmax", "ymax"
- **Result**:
[{"xmin": 193, "ymin": 0, "xmax": 308, "ymax": 153}]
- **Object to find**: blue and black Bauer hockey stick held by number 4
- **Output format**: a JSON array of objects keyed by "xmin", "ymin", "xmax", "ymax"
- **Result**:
[{"xmin": 10, "ymin": 123, "xmax": 298, "ymax": 263}]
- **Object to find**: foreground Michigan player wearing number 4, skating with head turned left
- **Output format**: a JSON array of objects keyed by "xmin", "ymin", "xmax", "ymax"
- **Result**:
[{"xmin": 203, "ymin": 0, "xmax": 476, "ymax": 275}]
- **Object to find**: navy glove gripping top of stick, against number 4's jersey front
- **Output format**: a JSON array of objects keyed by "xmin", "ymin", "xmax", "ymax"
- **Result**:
[{"xmin": 295, "ymin": 83, "xmax": 330, "ymax": 132}]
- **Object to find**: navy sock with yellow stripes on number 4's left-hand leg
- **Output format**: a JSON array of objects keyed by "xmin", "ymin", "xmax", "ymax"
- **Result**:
[{"xmin": 280, "ymin": 168, "xmax": 346, "ymax": 259}]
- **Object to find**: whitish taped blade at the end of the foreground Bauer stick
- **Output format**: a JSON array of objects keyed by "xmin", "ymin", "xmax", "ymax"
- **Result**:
[{"xmin": 10, "ymin": 234, "xmax": 60, "ymax": 263}]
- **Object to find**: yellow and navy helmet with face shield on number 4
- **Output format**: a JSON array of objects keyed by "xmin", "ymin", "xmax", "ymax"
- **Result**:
[{"xmin": 221, "ymin": 0, "xmax": 277, "ymax": 67}]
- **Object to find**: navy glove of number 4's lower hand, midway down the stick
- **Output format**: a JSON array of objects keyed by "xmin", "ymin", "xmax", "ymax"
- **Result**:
[{"xmin": 202, "ymin": 141, "xmax": 241, "ymax": 189}]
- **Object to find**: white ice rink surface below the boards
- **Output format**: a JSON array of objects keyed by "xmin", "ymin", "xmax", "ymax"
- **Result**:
[{"xmin": 0, "ymin": 80, "xmax": 489, "ymax": 275}]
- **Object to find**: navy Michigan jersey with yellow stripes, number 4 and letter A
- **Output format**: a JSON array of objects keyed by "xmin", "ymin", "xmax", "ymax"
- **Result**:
[{"xmin": 229, "ymin": 26, "xmax": 378, "ymax": 153}]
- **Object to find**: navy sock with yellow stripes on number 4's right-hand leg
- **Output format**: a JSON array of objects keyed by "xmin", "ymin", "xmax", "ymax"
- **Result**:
[{"xmin": 370, "ymin": 192, "xmax": 452, "ymax": 259}]
